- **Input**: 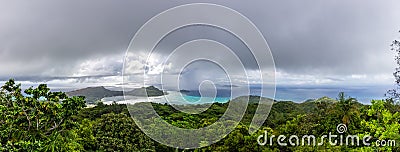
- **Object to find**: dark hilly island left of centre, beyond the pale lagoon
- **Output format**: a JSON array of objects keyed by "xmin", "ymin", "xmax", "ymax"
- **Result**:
[{"xmin": 66, "ymin": 86, "xmax": 166, "ymax": 104}]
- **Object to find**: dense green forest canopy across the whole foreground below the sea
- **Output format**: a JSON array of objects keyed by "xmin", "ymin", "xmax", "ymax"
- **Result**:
[{"xmin": 0, "ymin": 80, "xmax": 400, "ymax": 151}]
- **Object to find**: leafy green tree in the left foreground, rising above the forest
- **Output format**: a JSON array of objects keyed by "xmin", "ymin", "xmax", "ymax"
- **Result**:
[{"xmin": 0, "ymin": 79, "xmax": 85, "ymax": 151}]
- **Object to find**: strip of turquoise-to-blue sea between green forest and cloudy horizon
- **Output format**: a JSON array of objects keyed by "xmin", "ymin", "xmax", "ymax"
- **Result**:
[{"xmin": 103, "ymin": 86, "xmax": 390, "ymax": 104}]
